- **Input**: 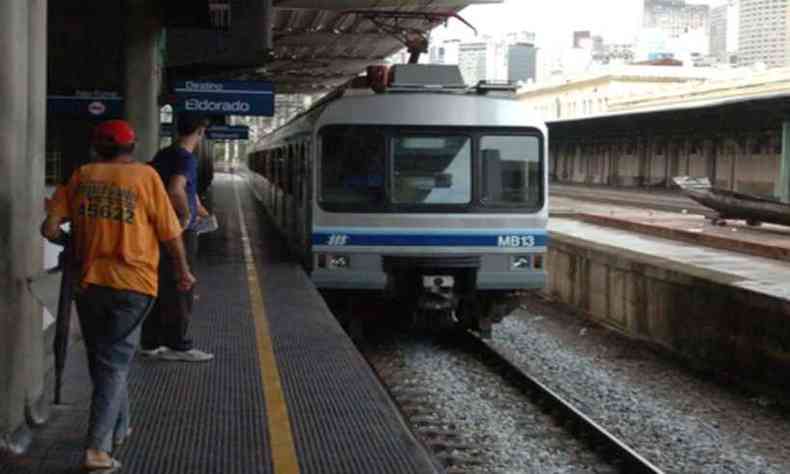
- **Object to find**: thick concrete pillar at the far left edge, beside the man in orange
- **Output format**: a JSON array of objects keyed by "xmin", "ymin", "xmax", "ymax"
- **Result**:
[{"xmin": 0, "ymin": 0, "xmax": 47, "ymax": 457}]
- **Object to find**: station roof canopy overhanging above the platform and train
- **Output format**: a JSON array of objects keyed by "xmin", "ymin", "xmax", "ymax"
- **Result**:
[{"xmin": 166, "ymin": 0, "xmax": 501, "ymax": 94}]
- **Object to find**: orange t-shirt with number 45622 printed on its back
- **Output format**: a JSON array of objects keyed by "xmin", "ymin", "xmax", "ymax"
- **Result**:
[{"xmin": 47, "ymin": 163, "xmax": 182, "ymax": 296}]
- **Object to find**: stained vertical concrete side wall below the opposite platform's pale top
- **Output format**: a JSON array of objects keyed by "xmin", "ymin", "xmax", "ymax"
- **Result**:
[{"xmin": 546, "ymin": 233, "xmax": 790, "ymax": 389}]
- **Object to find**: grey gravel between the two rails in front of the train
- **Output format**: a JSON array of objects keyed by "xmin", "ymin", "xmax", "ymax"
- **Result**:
[{"xmin": 365, "ymin": 336, "xmax": 618, "ymax": 474}]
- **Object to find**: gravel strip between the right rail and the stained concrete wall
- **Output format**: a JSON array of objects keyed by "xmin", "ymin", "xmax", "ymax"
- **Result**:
[{"xmin": 493, "ymin": 299, "xmax": 790, "ymax": 474}]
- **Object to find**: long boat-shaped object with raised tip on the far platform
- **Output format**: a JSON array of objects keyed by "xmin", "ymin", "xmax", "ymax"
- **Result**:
[{"xmin": 673, "ymin": 176, "xmax": 790, "ymax": 226}]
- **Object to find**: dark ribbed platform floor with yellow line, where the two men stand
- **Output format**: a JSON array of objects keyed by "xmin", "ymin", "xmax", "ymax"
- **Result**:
[{"xmin": 0, "ymin": 173, "xmax": 441, "ymax": 474}]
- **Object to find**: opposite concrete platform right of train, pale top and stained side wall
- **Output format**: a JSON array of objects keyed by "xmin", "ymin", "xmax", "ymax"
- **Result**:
[{"xmin": 548, "ymin": 218, "xmax": 790, "ymax": 388}]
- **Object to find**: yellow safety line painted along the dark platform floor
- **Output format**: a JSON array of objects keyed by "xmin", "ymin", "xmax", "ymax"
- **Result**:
[{"xmin": 233, "ymin": 177, "xmax": 299, "ymax": 474}]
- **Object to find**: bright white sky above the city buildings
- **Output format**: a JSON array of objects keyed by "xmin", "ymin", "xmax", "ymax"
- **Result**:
[{"xmin": 433, "ymin": 0, "xmax": 721, "ymax": 49}]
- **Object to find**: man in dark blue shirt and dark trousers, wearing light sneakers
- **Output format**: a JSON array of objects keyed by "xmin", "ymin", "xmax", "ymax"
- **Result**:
[{"xmin": 140, "ymin": 114, "xmax": 214, "ymax": 362}]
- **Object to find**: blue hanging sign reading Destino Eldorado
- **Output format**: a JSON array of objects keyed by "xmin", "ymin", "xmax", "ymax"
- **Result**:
[{"xmin": 175, "ymin": 81, "xmax": 274, "ymax": 117}]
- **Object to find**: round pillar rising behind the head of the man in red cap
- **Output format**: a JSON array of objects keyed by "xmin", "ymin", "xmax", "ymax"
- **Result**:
[{"xmin": 124, "ymin": 0, "xmax": 162, "ymax": 161}]
